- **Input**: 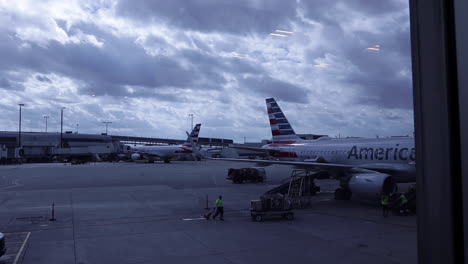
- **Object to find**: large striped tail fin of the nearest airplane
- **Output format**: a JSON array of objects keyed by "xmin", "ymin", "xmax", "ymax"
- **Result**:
[{"xmin": 266, "ymin": 98, "xmax": 302, "ymax": 143}]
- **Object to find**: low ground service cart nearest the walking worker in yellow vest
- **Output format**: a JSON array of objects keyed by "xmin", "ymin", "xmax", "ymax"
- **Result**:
[{"xmin": 250, "ymin": 194, "xmax": 294, "ymax": 221}]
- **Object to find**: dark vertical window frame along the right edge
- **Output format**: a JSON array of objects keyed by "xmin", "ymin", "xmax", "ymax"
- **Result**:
[{"xmin": 409, "ymin": 0, "xmax": 468, "ymax": 263}]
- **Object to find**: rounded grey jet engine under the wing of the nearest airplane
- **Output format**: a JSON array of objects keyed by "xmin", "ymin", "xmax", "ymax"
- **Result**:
[{"xmin": 348, "ymin": 171, "xmax": 397, "ymax": 201}]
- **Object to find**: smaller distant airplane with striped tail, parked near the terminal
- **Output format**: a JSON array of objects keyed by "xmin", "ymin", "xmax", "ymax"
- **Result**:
[{"xmin": 131, "ymin": 124, "xmax": 201, "ymax": 163}]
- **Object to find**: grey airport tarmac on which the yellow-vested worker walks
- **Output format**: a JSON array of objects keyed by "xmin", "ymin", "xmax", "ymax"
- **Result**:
[{"xmin": 0, "ymin": 161, "xmax": 417, "ymax": 264}]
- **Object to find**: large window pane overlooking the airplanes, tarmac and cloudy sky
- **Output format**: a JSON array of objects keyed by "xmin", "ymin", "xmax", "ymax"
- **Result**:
[{"xmin": 0, "ymin": 0, "xmax": 416, "ymax": 263}]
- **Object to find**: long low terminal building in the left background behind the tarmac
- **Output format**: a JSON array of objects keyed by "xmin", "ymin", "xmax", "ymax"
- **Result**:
[{"xmin": 0, "ymin": 131, "xmax": 233, "ymax": 162}]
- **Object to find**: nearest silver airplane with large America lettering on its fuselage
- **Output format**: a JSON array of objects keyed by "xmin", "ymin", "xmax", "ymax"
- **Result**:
[{"xmin": 203, "ymin": 98, "xmax": 416, "ymax": 200}]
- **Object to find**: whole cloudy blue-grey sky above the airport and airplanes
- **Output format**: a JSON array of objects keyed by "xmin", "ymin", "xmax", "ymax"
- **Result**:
[{"xmin": 0, "ymin": 0, "xmax": 413, "ymax": 141}]
